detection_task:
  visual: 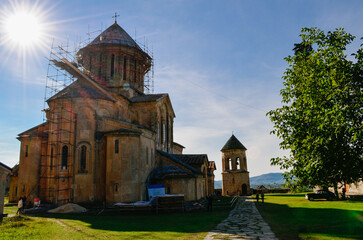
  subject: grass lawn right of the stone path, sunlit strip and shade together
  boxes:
[253,194,363,239]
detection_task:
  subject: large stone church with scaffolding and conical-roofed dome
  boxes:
[10,21,216,204]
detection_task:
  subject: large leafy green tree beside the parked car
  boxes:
[267,28,363,196]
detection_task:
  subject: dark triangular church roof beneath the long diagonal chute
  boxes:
[52,80,113,101]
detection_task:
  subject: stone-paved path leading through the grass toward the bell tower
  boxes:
[204,197,277,240]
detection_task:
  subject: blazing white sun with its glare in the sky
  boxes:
[0,0,52,60]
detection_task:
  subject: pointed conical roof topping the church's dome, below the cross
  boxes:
[88,22,142,50]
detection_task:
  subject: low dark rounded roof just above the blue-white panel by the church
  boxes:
[149,165,197,180]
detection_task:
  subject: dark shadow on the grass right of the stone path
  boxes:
[257,203,363,239]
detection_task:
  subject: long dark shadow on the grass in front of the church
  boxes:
[27,200,235,233]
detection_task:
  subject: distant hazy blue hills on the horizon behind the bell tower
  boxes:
[214,173,285,188]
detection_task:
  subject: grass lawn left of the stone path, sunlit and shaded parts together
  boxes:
[0,197,231,239]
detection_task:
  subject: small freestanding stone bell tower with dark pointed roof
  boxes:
[221,134,250,196]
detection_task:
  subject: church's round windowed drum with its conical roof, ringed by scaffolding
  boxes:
[77,22,152,94]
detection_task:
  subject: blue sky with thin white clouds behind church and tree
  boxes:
[0,0,363,180]
